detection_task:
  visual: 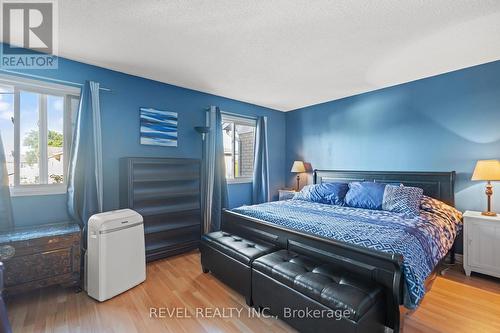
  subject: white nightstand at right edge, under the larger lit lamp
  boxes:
[464,211,500,277]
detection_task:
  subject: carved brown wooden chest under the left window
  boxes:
[0,222,81,294]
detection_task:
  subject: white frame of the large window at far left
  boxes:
[0,74,80,197]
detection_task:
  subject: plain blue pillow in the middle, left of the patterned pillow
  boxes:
[345,182,386,210]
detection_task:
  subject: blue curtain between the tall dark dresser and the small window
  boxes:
[202,106,228,232]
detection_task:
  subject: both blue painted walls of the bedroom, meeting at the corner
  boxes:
[7,49,500,233]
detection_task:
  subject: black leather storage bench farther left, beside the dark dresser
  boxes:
[200,231,275,305]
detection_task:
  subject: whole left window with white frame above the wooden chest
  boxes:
[0,75,80,196]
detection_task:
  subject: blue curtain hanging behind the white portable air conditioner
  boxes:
[67,81,103,248]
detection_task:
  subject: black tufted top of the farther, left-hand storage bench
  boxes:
[202,231,274,265]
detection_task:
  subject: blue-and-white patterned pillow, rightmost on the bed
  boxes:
[382,185,424,217]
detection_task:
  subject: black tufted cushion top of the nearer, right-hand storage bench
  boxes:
[252,250,383,321]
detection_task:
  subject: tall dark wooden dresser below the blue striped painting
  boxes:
[120,157,201,261]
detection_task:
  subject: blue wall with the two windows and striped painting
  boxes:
[8,55,285,225]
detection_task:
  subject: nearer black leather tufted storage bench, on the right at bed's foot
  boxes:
[252,250,385,333]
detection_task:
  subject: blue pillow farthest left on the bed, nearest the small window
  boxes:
[293,183,349,205]
